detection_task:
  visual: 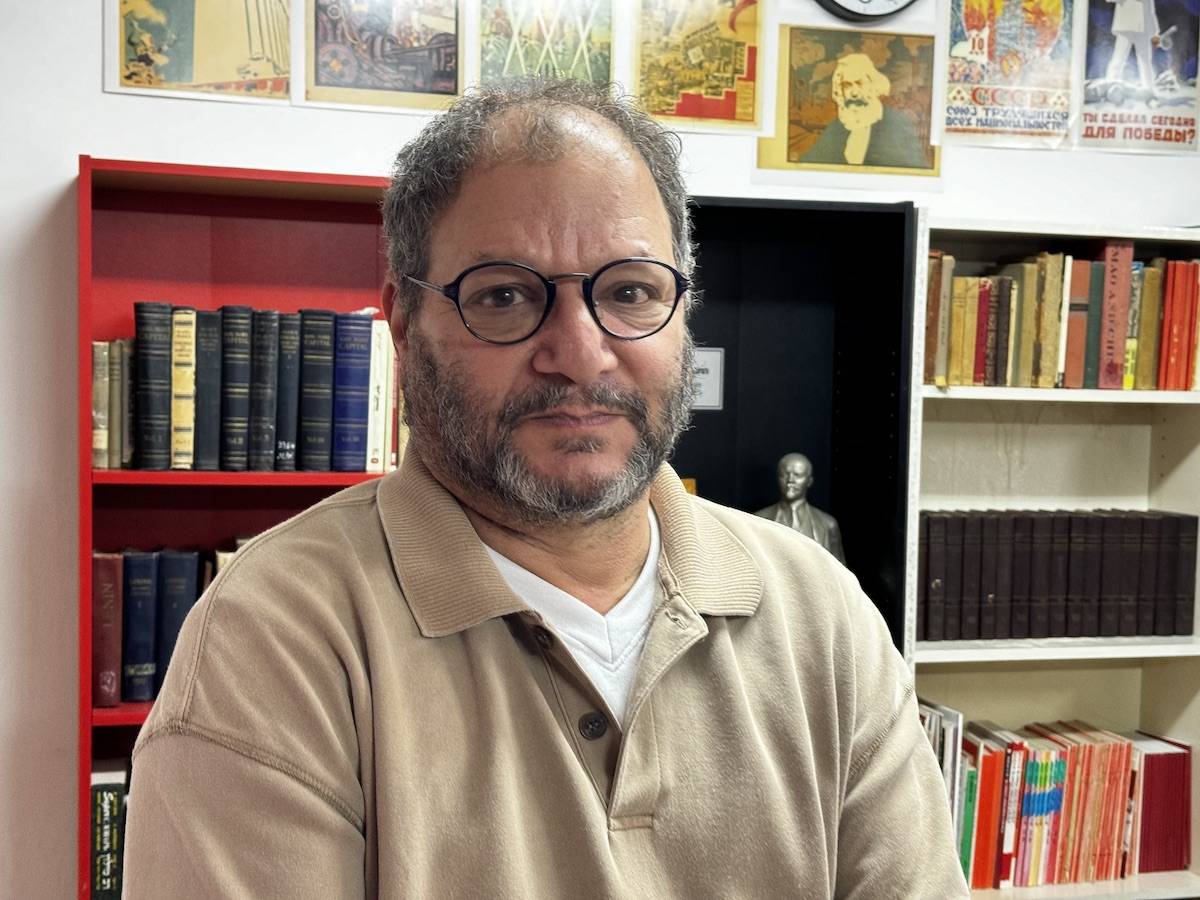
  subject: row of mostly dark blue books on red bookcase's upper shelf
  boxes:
[91,302,404,473]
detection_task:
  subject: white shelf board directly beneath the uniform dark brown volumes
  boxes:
[913,635,1200,666]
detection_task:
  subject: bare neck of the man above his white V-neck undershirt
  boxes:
[463,497,650,616]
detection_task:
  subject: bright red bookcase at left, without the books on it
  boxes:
[77,156,386,898]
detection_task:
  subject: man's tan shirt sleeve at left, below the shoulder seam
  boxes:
[122,733,365,900]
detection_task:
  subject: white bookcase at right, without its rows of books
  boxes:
[905,215,1200,900]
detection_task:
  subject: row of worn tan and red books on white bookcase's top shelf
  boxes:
[924,240,1200,390]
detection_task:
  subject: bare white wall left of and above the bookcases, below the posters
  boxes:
[0,0,1200,898]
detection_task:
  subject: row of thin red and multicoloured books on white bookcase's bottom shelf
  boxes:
[919,701,1192,889]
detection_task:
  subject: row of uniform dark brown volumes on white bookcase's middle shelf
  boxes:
[917,510,1198,641]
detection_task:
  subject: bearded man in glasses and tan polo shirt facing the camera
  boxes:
[126,83,966,899]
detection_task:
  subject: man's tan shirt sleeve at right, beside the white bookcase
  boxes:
[836,598,971,900]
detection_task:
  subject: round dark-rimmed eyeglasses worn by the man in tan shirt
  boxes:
[404,257,691,343]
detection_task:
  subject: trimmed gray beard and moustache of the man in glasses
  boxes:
[401,329,695,527]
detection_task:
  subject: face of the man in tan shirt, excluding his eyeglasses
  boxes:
[398,120,692,524]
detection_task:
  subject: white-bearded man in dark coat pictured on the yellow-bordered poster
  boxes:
[803,53,929,169]
